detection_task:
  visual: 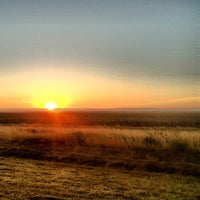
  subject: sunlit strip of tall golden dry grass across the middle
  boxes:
[0,125,200,151]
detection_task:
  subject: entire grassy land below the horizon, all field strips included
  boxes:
[0,112,200,199]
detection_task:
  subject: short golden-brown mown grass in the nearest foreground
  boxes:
[0,158,200,200]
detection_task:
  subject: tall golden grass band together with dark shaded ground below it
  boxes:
[0,125,200,177]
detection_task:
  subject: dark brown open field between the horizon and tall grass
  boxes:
[0,111,200,128]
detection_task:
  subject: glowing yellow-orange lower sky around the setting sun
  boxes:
[0,63,200,108]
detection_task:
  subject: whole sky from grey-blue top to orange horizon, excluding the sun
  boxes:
[0,0,200,109]
